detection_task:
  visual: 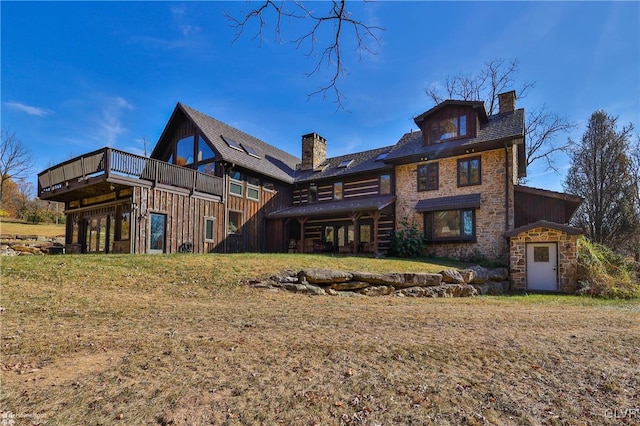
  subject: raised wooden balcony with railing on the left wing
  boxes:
[38,148,224,201]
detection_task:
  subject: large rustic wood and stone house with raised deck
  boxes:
[38,91,581,291]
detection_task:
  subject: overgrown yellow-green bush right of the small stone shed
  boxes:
[578,238,640,299]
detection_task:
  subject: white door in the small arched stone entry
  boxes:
[527,243,558,291]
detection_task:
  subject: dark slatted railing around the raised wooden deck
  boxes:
[38,148,223,198]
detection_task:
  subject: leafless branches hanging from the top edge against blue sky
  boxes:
[226,0,383,109]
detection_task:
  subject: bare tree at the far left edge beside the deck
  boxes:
[0,127,33,209]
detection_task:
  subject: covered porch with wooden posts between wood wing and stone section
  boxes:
[269,196,395,254]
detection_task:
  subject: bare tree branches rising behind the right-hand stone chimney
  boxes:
[426,58,575,171]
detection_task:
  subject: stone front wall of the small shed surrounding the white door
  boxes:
[510,227,580,293]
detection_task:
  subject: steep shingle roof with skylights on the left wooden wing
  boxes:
[178,103,301,183]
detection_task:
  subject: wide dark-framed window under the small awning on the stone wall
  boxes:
[424,209,476,241]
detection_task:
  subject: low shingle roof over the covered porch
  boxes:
[269,195,396,219]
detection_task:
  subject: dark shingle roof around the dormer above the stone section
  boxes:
[386,109,524,162]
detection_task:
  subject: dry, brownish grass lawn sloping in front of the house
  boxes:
[0,253,640,425]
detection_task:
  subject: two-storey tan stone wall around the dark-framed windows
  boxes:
[395,148,517,262]
